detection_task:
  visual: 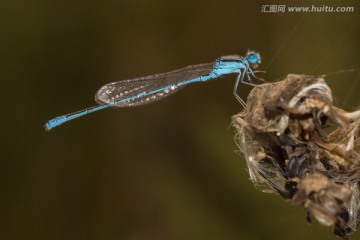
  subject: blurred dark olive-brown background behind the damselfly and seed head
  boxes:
[0,0,360,240]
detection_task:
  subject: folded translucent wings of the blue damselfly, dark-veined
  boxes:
[95,63,214,107]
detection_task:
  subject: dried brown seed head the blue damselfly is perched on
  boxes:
[233,74,360,237]
